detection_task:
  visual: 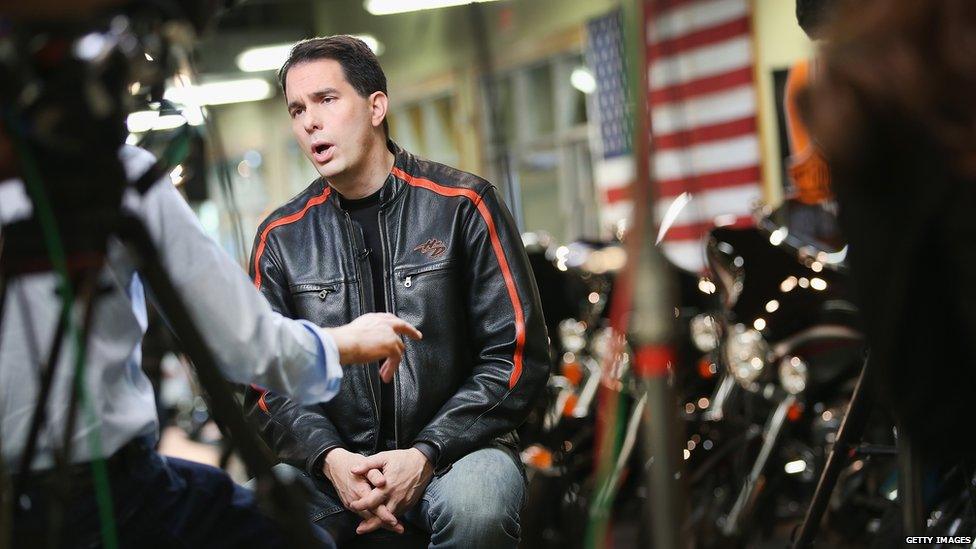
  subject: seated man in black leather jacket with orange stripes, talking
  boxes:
[245,36,549,547]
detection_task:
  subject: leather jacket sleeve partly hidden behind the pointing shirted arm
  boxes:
[244,228,342,476]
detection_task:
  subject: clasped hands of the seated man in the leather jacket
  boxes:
[322,448,434,534]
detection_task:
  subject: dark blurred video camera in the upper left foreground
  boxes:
[0,0,230,272]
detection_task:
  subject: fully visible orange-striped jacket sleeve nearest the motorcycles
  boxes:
[416,186,549,467]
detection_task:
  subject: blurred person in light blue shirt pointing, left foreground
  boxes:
[0,116,420,547]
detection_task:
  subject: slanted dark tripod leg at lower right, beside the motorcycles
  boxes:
[793,358,874,549]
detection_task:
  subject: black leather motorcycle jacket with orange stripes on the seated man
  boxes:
[245,143,549,474]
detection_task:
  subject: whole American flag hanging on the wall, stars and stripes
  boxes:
[587,0,762,272]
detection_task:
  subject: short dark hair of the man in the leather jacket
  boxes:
[278,34,390,136]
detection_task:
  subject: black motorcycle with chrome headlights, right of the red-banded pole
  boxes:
[687,202,896,546]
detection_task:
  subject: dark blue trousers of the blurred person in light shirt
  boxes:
[14,449,335,548]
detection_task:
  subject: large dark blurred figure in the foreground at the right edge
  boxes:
[809,0,976,463]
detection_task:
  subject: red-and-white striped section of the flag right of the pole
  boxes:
[645,0,762,271]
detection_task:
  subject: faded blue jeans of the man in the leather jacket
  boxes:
[277,445,525,549]
